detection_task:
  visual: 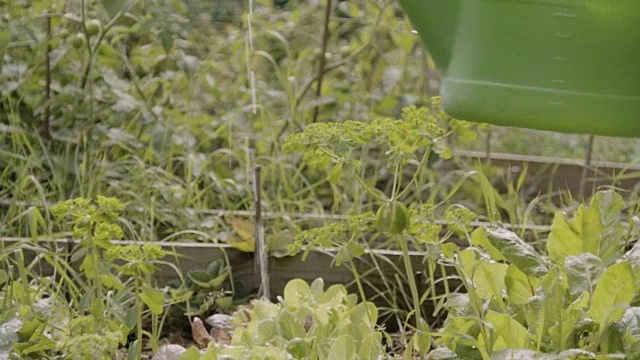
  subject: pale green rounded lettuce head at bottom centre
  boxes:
[204,279,383,360]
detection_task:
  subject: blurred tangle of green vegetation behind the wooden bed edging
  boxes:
[0,0,640,240]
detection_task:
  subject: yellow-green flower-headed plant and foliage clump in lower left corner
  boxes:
[0,196,175,359]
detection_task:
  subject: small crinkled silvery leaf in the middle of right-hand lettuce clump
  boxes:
[564,253,604,296]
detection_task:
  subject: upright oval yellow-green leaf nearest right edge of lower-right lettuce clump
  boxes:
[589,261,635,332]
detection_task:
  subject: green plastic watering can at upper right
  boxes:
[401,0,640,137]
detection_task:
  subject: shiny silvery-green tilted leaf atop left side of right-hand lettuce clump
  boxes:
[486,229,549,277]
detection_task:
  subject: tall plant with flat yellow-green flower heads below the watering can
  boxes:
[284,99,470,353]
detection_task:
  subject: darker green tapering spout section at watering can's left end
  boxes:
[400,0,461,70]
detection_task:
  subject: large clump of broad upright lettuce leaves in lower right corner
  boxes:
[437,191,640,359]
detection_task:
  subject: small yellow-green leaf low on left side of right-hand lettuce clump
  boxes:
[478,310,531,351]
